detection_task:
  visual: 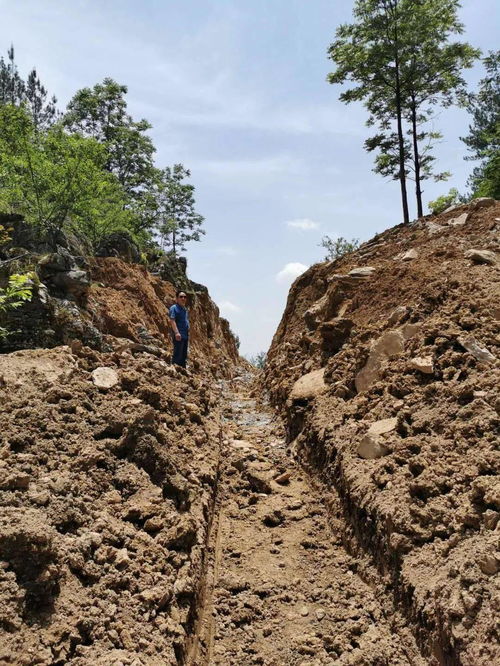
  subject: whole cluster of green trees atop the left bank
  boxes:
[0,48,205,255]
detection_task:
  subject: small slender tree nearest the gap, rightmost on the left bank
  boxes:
[156,164,205,254]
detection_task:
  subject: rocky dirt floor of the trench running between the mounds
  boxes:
[187,378,430,666]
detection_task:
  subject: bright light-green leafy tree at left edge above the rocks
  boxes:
[0,104,131,246]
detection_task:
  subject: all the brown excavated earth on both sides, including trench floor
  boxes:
[0,201,500,666]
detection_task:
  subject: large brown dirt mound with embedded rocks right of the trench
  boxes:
[266,200,500,666]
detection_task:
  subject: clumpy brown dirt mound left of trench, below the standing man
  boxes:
[0,344,227,666]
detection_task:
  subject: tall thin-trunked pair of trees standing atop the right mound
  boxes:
[328,0,479,223]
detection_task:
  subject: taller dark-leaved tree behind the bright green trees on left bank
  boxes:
[63,78,155,198]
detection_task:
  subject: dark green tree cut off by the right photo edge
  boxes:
[462,51,500,199]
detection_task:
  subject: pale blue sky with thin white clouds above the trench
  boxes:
[0,0,500,355]
